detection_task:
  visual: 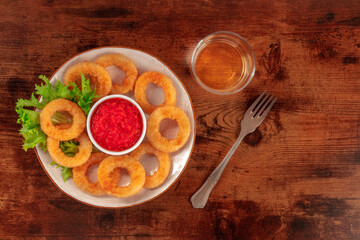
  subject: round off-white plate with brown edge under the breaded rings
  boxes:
[36,47,195,208]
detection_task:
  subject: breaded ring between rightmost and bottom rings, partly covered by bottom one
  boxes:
[130,143,171,188]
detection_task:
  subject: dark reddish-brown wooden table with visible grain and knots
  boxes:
[0,0,360,240]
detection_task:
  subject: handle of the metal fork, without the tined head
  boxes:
[190,131,247,208]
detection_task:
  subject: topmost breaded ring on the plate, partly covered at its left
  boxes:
[95,54,139,94]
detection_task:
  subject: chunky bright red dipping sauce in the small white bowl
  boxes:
[90,98,143,152]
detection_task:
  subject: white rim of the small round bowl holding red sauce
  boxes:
[86,94,146,155]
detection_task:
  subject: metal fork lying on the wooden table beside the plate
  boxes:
[190,91,277,208]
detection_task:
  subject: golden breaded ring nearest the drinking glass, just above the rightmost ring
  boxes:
[134,72,176,114]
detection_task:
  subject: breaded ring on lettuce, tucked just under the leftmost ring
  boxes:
[46,132,92,168]
